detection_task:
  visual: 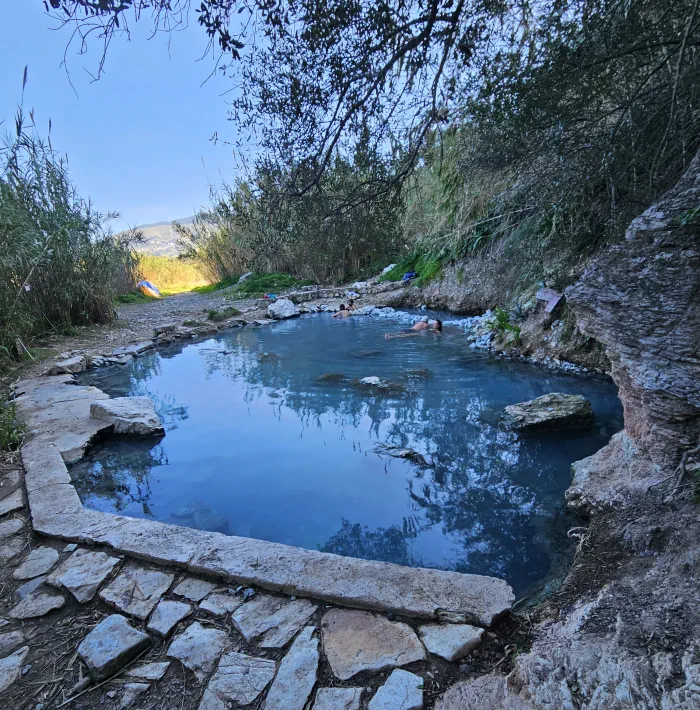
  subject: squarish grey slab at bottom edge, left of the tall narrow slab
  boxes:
[200,652,277,707]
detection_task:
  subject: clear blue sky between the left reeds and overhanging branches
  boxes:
[0,0,234,230]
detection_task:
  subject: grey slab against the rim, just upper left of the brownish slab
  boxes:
[231,594,317,648]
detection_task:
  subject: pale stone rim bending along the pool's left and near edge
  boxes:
[10,342,515,626]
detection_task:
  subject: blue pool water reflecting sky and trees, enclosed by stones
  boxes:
[71,314,622,594]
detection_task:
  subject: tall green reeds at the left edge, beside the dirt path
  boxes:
[0,98,137,368]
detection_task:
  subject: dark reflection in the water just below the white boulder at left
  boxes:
[70,437,168,516]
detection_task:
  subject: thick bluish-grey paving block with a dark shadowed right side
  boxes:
[78,614,151,681]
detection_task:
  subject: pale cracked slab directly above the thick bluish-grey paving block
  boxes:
[100,565,175,619]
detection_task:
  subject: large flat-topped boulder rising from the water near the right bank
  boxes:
[503,392,595,432]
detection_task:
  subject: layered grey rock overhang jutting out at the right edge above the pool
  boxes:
[566,154,700,466]
